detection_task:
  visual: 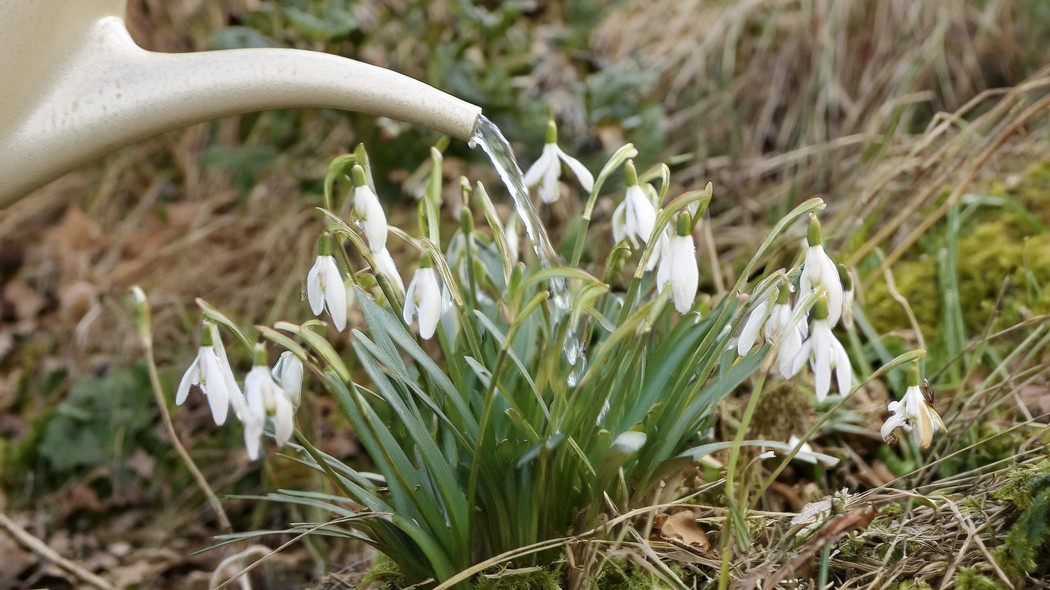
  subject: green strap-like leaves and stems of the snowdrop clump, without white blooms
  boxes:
[197,144,835,588]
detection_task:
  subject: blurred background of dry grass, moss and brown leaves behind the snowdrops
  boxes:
[6,0,1050,586]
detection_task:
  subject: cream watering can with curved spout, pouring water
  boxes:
[0,0,481,207]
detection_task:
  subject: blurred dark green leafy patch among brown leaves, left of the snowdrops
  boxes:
[38,365,156,473]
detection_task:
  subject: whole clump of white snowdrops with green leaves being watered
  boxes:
[159,124,928,586]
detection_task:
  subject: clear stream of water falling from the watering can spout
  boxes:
[470,115,585,369]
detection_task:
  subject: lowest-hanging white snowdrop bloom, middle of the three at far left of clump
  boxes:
[245,343,295,460]
